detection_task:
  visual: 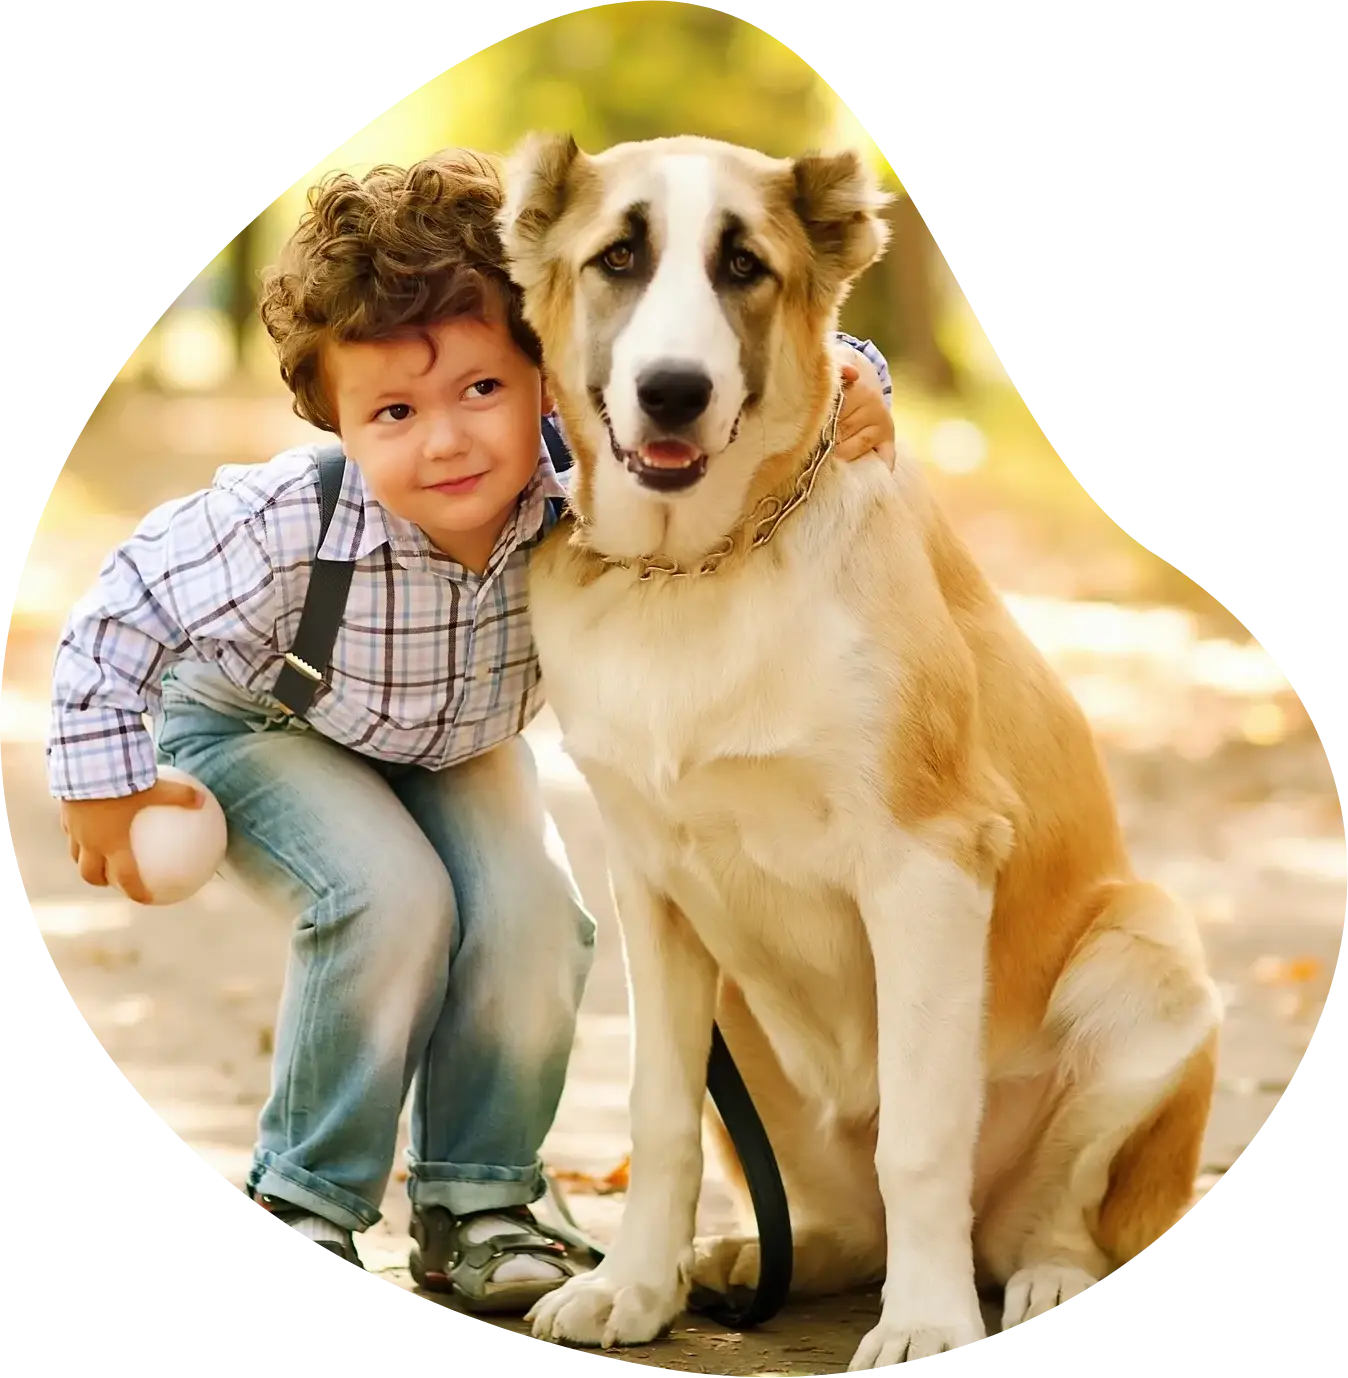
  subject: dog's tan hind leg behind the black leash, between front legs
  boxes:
[693,980,885,1297]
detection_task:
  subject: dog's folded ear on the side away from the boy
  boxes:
[791,149,893,295]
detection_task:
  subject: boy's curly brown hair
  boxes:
[261,149,543,431]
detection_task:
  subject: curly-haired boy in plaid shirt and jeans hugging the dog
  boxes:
[48,150,893,1312]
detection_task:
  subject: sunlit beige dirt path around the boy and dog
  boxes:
[0,385,1348,1378]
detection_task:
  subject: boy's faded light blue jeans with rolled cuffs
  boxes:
[156,671,595,1231]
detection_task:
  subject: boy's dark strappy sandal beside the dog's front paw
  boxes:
[409,1206,593,1315]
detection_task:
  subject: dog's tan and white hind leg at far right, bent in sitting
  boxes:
[976,885,1221,1330]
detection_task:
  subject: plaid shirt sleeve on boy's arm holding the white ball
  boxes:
[47,488,276,799]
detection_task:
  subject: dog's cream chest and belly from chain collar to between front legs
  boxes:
[535,548,884,1113]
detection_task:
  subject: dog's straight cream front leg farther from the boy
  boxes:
[848,835,992,1374]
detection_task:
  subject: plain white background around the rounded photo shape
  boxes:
[15,6,1344,1374]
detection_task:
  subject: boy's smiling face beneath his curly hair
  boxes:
[323,299,551,572]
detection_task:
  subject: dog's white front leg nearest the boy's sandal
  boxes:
[525,847,717,1349]
